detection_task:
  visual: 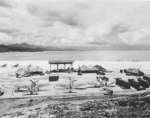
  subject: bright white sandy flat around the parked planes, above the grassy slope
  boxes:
[0,61,145,98]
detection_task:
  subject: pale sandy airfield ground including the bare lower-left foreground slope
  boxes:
[0,61,150,118]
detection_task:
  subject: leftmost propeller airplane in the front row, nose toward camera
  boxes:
[15,80,50,95]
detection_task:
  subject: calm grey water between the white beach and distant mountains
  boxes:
[0,51,150,61]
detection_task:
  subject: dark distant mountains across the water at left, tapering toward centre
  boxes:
[0,43,78,52]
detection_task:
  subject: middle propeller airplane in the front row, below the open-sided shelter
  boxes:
[55,77,85,93]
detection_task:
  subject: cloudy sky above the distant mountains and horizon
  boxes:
[0,0,150,47]
